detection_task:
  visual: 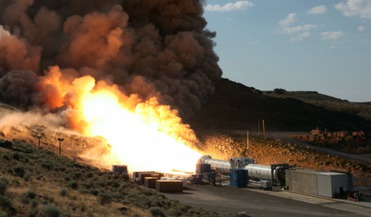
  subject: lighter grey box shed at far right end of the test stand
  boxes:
[316,172,351,198]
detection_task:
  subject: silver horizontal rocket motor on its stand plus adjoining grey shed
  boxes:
[191,155,353,197]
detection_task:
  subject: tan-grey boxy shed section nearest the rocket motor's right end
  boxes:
[285,169,318,195]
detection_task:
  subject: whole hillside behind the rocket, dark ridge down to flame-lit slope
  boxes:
[189,79,371,186]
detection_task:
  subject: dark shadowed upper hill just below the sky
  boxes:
[189,79,371,132]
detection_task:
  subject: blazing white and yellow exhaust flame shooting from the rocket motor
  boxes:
[44,69,202,172]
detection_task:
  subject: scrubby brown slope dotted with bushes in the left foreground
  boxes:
[0,140,218,217]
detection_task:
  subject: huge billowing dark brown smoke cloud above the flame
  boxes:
[0,0,222,115]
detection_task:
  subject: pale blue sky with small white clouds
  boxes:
[204,0,371,102]
